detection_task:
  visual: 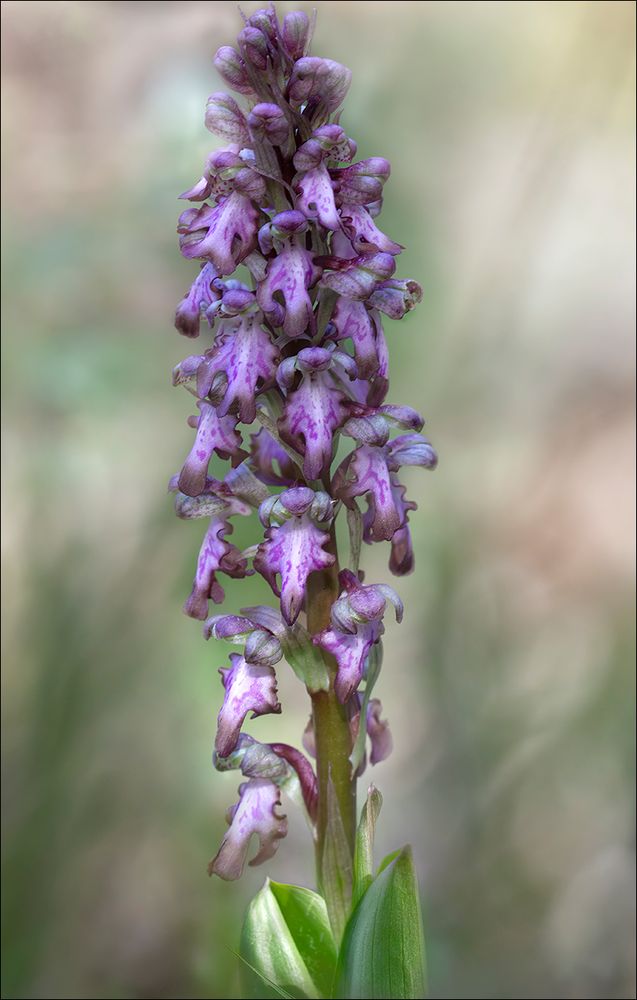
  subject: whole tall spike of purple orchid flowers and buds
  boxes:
[171,9,436,879]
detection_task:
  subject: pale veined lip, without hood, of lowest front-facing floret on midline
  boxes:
[254,514,335,625]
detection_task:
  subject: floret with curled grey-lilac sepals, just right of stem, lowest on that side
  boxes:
[314,570,403,703]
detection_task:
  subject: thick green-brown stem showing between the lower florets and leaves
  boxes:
[306,528,356,936]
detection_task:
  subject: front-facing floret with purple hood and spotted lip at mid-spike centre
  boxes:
[278,347,355,480]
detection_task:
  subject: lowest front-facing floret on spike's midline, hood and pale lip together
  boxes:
[254,487,335,625]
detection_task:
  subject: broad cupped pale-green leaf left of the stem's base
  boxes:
[240,879,336,998]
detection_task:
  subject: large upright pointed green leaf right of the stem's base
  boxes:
[334,847,426,1000]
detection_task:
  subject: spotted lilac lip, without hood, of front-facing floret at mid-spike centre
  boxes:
[279,366,349,479]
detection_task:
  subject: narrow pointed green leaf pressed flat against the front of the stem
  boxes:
[320,778,353,943]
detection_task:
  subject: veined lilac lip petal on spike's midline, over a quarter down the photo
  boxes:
[257,245,321,339]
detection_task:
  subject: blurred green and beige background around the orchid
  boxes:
[2,0,635,1000]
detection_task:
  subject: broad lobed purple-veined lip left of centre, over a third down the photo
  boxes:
[201,312,279,424]
